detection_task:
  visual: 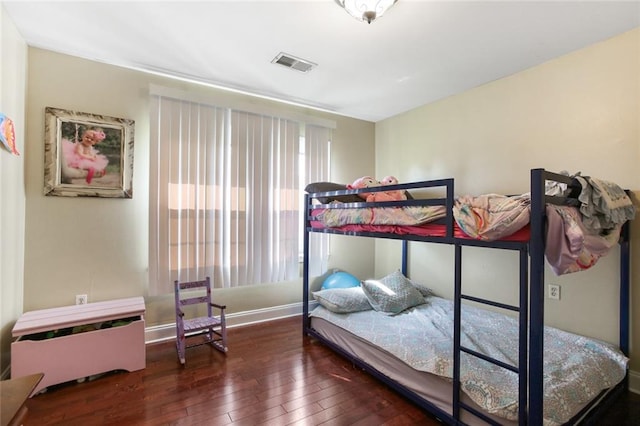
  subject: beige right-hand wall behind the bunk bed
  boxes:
[376,29,640,371]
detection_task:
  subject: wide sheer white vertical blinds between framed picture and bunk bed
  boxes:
[149,95,301,294]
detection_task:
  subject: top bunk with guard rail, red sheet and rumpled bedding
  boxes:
[305,169,636,260]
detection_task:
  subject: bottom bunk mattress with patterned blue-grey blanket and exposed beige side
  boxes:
[307,296,628,425]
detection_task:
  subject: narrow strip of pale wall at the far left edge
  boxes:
[0,5,27,373]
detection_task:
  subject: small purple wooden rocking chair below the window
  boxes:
[174,277,227,365]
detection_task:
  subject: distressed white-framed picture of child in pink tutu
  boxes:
[44,107,135,198]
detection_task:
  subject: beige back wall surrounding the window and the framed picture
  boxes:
[24,48,374,326]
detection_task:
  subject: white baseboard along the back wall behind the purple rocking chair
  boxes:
[144,301,317,344]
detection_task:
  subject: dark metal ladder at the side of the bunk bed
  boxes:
[453,243,529,425]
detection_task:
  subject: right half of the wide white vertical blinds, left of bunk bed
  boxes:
[229,111,300,286]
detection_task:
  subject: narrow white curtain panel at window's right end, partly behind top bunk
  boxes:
[304,124,332,276]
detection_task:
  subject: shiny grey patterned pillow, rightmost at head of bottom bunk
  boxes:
[361,271,425,315]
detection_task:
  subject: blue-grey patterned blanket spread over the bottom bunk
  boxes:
[311,296,628,425]
